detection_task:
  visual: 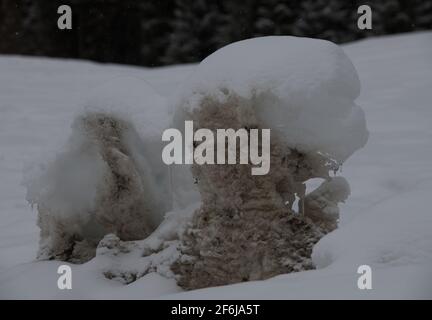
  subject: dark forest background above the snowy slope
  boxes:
[0,0,432,66]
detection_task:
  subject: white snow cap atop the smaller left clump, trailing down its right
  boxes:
[83,76,172,210]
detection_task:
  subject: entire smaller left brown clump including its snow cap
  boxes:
[27,79,170,262]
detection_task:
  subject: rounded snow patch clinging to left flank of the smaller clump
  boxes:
[24,130,107,222]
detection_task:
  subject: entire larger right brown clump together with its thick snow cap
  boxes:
[169,37,367,289]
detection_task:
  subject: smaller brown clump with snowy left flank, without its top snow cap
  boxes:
[27,113,166,262]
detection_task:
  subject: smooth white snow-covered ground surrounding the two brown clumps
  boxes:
[0,33,432,299]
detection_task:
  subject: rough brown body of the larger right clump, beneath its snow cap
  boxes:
[173,94,339,289]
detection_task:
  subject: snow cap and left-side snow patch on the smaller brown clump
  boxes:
[24,76,171,224]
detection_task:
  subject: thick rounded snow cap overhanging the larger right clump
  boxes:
[178,36,368,162]
